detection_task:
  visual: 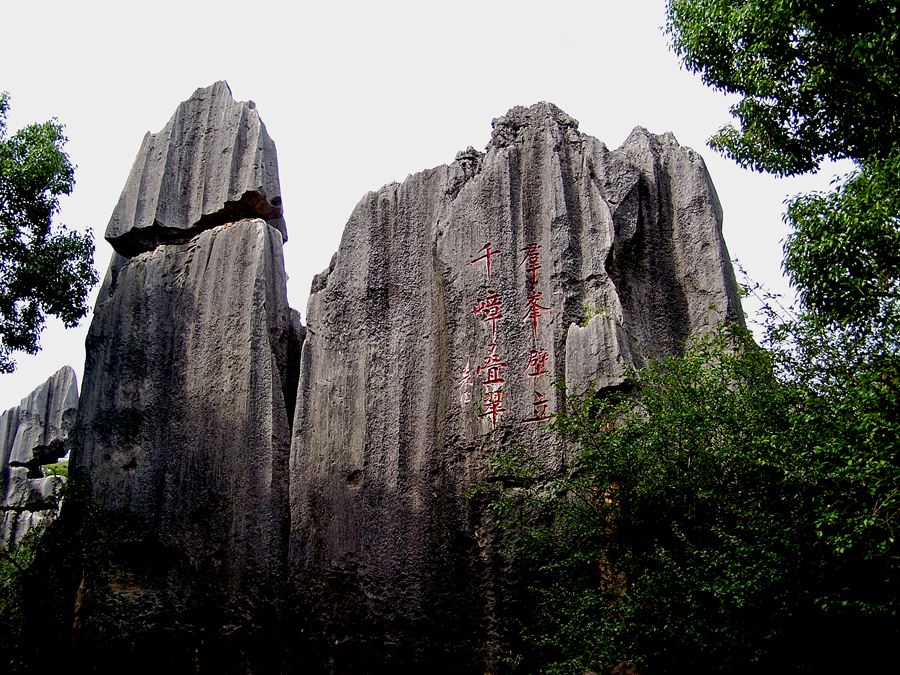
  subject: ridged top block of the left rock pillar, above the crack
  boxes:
[106,81,287,257]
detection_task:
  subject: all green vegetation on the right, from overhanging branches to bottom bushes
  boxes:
[491,0,900,673]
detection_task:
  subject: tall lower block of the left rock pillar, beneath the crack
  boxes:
[73,220,299,628]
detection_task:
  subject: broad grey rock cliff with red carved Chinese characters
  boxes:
[290,103,741,672]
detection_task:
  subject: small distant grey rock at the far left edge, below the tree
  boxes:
[0,366,78,547]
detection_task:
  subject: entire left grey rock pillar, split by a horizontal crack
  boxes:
[72,83,303,654]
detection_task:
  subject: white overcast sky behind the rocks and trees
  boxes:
[0,0,834,410]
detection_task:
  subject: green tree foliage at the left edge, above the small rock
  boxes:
[0,93,97,372]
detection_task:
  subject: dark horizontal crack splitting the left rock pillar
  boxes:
[107,190,287,258]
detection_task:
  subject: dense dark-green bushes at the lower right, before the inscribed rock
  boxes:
[491,324,900,673]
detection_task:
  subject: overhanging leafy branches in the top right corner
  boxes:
[667,0,900,175]
